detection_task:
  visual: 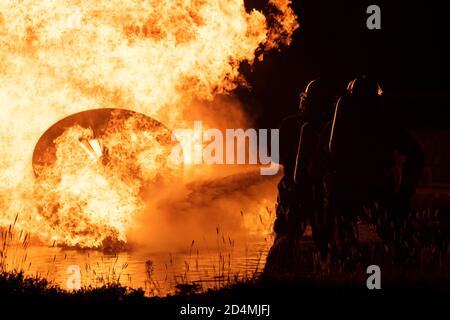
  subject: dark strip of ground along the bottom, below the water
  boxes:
[0,273,450,319]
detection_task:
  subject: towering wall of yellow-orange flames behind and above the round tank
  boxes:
[0,0,297,248]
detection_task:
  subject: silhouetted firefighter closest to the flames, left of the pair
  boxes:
[266,79,336,270]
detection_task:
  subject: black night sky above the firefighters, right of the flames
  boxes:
[238,0,450,127]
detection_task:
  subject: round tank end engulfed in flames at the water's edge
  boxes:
[33,109,177,249]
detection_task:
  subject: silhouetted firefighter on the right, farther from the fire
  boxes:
[327,77,423,258]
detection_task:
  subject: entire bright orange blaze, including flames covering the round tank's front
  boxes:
[0,0,297,247]
